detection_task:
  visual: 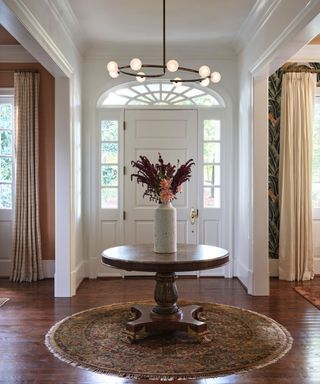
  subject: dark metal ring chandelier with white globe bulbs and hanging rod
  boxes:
[107,0,221,87]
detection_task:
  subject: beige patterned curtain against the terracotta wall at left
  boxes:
[11,72,43,282]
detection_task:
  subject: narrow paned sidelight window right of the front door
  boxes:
[203,120,221,208]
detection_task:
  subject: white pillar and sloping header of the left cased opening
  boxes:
[0,0,84,296]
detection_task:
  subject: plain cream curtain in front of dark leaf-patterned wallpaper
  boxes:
[279,73,316,281]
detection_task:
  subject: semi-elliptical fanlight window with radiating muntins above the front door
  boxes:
[98,82,225,107]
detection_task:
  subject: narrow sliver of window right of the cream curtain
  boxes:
[312,87,320,209]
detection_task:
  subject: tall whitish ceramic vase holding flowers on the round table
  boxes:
[154,203,177,253]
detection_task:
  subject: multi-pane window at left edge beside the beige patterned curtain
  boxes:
[0,90,14,209]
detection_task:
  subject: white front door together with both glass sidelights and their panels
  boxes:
[92,109,232,277]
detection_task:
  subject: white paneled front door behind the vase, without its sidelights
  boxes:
[124,110,198,249]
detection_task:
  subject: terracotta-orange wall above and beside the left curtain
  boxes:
[0,63,55,260]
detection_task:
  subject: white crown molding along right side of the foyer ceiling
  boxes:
[233,0,281,54]
